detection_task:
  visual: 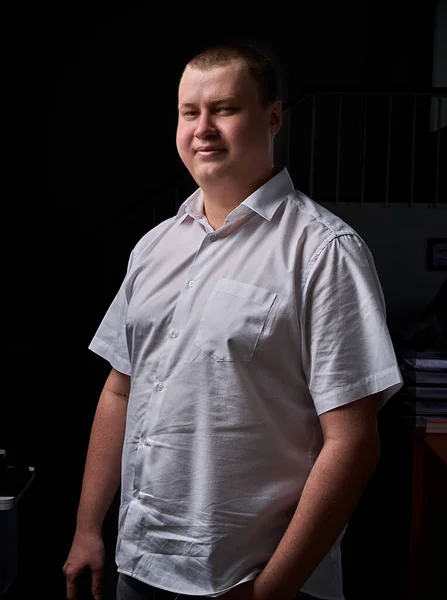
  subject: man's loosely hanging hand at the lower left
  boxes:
[62,532,105,600]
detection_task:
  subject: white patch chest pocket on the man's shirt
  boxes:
[194,278,276,362]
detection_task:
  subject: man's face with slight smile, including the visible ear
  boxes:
[177,60,281,187]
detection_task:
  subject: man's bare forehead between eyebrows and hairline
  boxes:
[178,60,257,104]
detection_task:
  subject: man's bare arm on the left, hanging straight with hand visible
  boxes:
[63,369,130,600]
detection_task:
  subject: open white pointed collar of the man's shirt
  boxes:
[175,167,294,221]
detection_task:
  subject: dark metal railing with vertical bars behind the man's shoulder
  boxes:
[285,88,447,208]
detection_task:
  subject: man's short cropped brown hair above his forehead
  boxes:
[183,42,278,106]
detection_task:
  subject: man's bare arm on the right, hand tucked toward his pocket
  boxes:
[253,396,380,600]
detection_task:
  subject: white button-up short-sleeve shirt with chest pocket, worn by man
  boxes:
[89,169,402,600]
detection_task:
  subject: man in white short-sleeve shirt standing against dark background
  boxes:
[64,45,402,600]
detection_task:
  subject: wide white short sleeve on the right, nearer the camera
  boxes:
[301,234,402,414]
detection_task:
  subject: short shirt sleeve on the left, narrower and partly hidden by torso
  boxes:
[88,250,133,375]
